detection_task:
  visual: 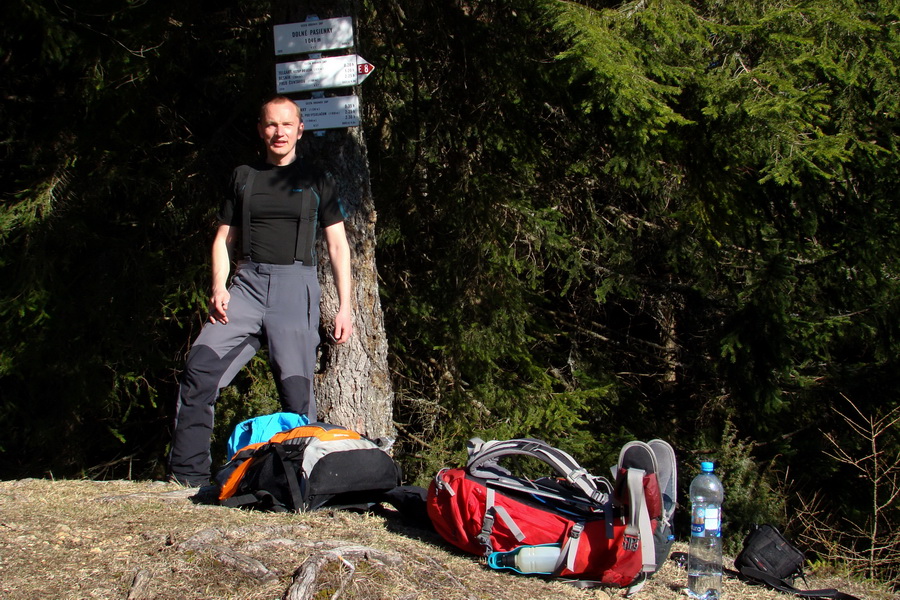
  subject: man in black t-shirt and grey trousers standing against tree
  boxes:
[169,96,353,487]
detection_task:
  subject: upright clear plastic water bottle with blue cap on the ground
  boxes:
[688,462,725,600]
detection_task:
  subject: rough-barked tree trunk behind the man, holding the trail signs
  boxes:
[273,0,394,438]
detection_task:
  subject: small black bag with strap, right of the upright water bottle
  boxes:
[728,525,859,600]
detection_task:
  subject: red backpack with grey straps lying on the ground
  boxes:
[427,439,674,591]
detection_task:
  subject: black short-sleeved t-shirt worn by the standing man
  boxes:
[218,159,344,265]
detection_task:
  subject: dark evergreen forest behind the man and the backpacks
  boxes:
[0,0,900,584]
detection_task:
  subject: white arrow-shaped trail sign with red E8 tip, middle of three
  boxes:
[275,54,375,94]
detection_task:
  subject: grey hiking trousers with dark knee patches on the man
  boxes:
[169,260,321,485]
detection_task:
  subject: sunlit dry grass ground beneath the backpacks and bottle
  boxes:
[0,479,891,600]
